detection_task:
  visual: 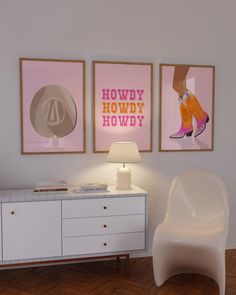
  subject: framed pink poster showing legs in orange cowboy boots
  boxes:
[159,64,215,151]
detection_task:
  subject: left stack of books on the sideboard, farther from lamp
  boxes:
[33,180,68,193]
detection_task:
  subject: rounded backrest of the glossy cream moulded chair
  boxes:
[165,170,229,232]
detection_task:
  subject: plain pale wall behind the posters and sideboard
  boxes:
[0,0,236,253]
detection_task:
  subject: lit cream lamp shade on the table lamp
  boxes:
[107,142,141,163]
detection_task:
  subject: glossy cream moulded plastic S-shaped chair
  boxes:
[153,171,229,295]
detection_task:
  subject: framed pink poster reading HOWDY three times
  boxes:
[93,61,153,152]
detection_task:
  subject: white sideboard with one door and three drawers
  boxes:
[0,186,147,267]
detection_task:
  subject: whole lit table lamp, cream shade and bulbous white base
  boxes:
[107,142,141,190]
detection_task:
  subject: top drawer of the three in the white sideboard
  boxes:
[62,197,145,218]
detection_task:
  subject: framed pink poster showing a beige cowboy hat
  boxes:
[20,58,85,154]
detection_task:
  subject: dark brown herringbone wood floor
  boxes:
[0,250,236,295]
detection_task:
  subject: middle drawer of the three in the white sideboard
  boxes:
[62,215,145,237]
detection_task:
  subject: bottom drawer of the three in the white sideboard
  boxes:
[63,233,145,255]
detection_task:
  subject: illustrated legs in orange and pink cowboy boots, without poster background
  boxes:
[170,65,209,138]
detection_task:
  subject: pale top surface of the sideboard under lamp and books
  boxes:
[0,185,147,203]
